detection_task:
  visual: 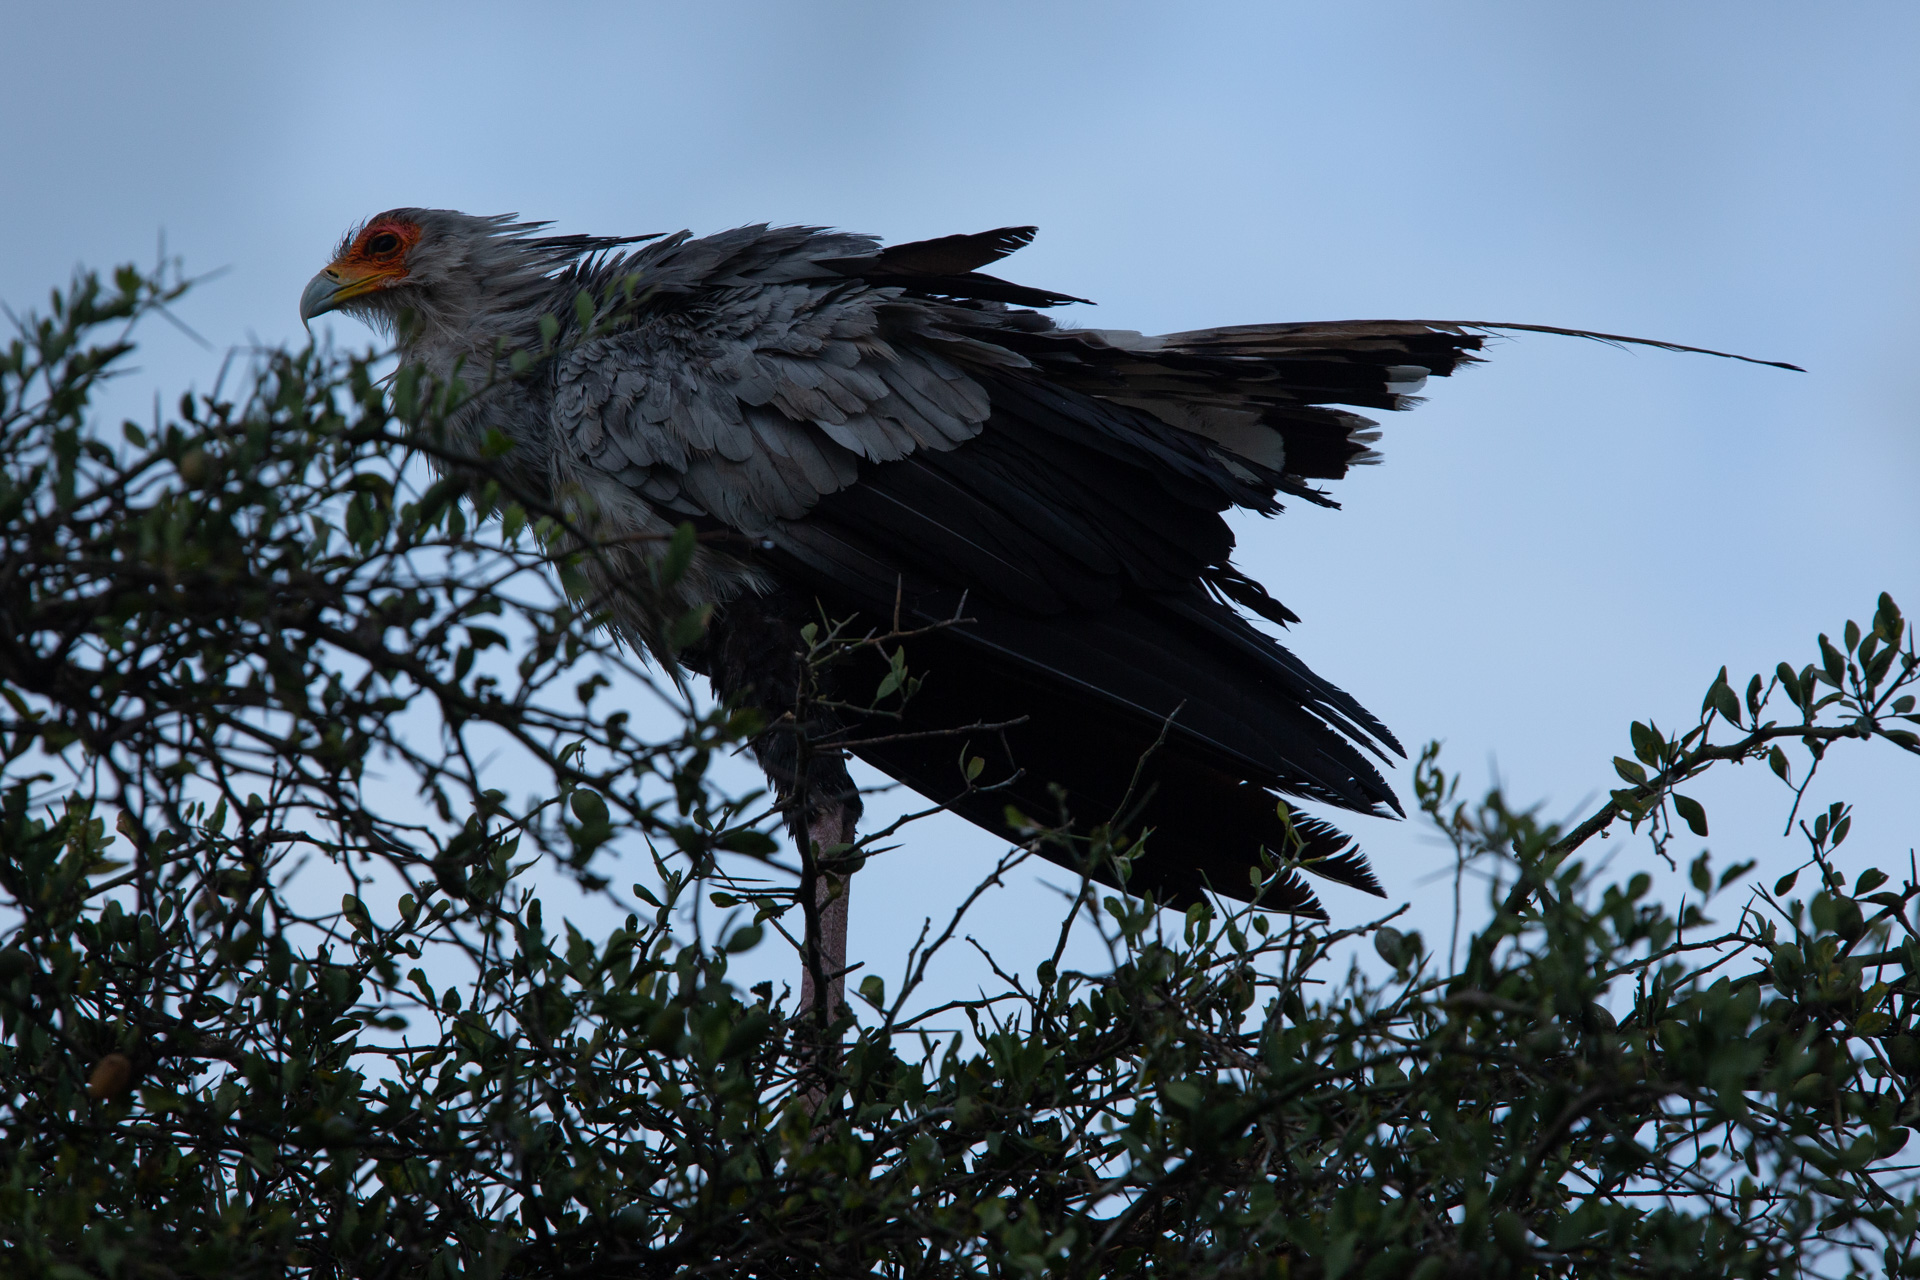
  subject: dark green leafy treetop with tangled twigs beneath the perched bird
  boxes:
[11,271,1920,1280]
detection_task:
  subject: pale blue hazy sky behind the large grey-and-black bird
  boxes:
[0,0,1920,990]
